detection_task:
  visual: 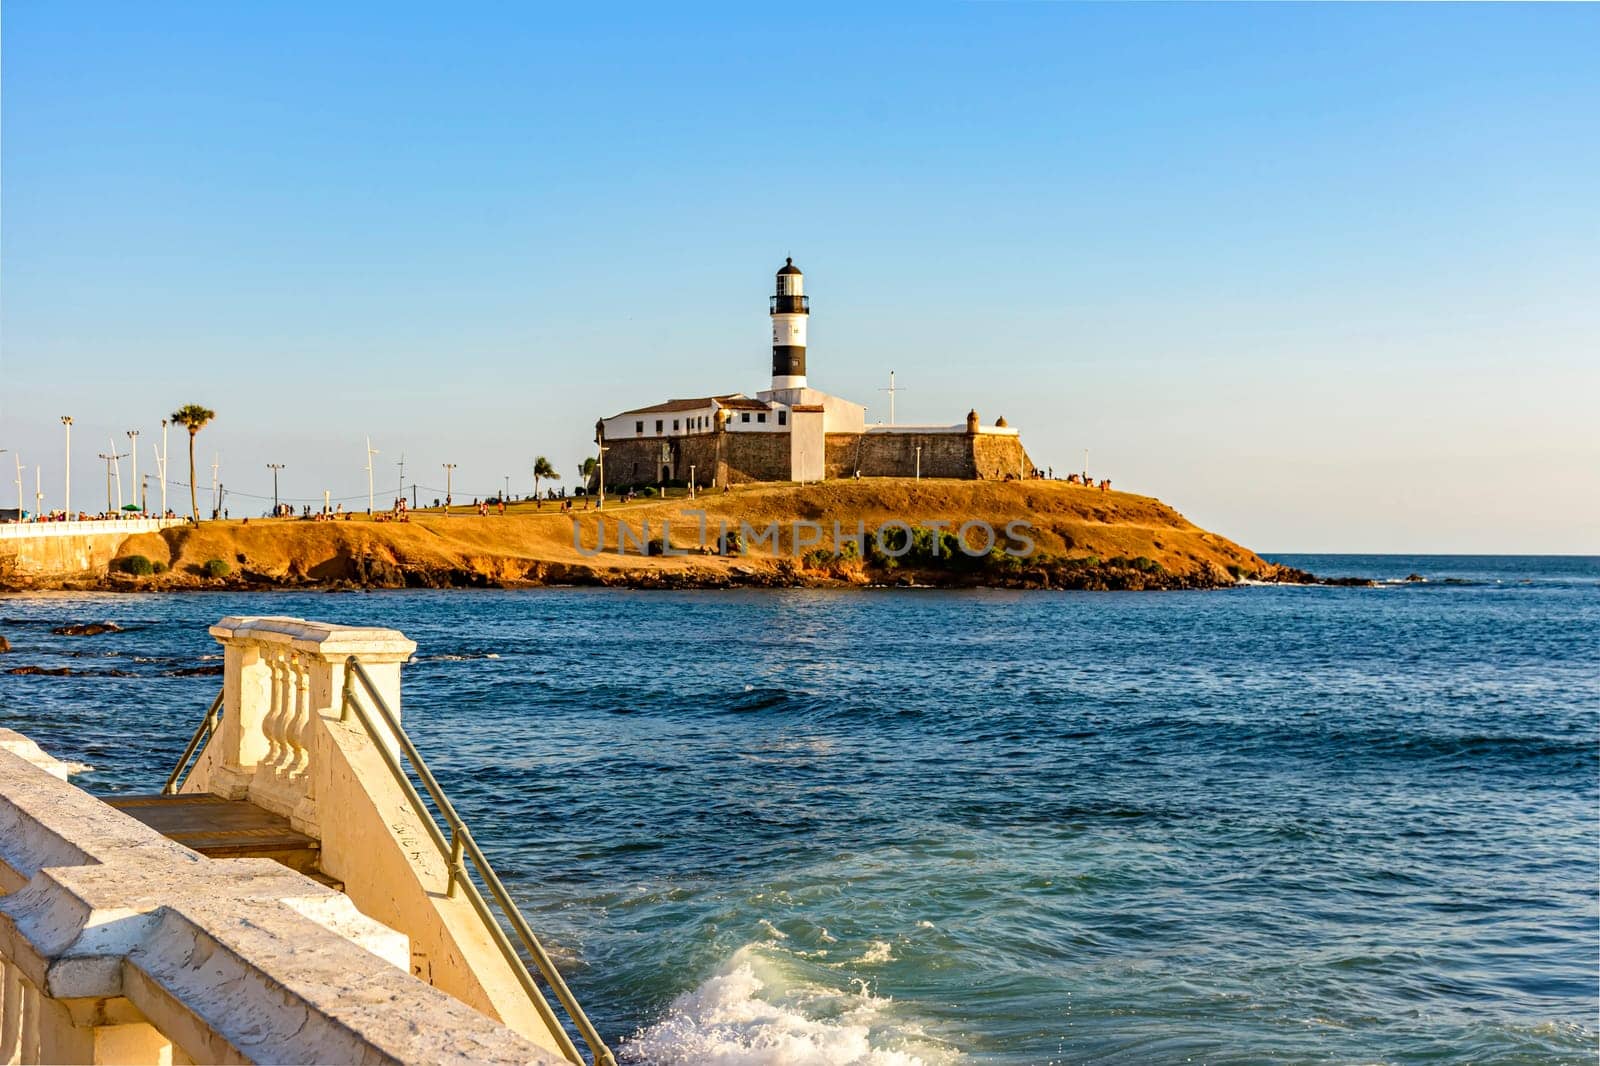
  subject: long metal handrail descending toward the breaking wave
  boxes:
[339,655,616,1066]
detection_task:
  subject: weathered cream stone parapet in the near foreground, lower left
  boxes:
[0,731,560,1063]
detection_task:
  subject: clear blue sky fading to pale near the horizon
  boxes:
[0,0,1600,552]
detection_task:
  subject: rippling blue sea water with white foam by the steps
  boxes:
[0,555,1600,1066]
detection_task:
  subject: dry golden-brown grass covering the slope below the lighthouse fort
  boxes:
[120,479,1269,586]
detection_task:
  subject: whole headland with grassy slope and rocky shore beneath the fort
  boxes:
[0,479,1293,591]
